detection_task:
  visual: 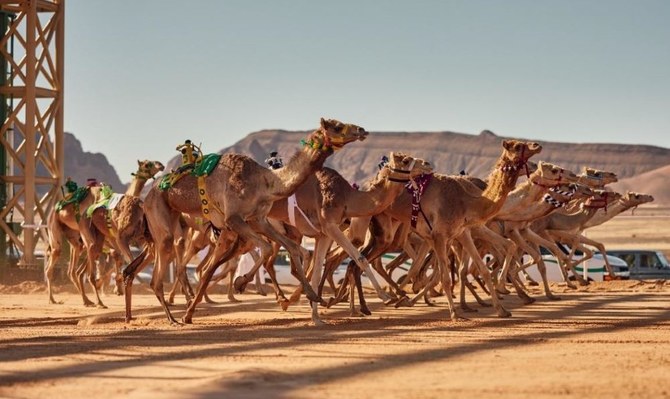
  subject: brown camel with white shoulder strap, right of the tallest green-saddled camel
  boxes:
[255,152,432,325]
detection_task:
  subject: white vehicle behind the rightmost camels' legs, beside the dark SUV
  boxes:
[523,244,630,282]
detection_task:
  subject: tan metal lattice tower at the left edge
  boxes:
[0,0,65,265]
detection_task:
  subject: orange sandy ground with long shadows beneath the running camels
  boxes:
[0,281,670,398]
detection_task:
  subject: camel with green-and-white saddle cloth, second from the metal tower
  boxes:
[80,160,165,295]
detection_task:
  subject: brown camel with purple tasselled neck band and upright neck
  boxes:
[344,140,542,320]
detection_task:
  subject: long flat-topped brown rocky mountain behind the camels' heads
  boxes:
[168,130,670,204]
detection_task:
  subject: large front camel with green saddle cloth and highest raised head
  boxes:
[124,118,368,324]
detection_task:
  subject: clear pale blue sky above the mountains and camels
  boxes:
[64,0,670,182]
